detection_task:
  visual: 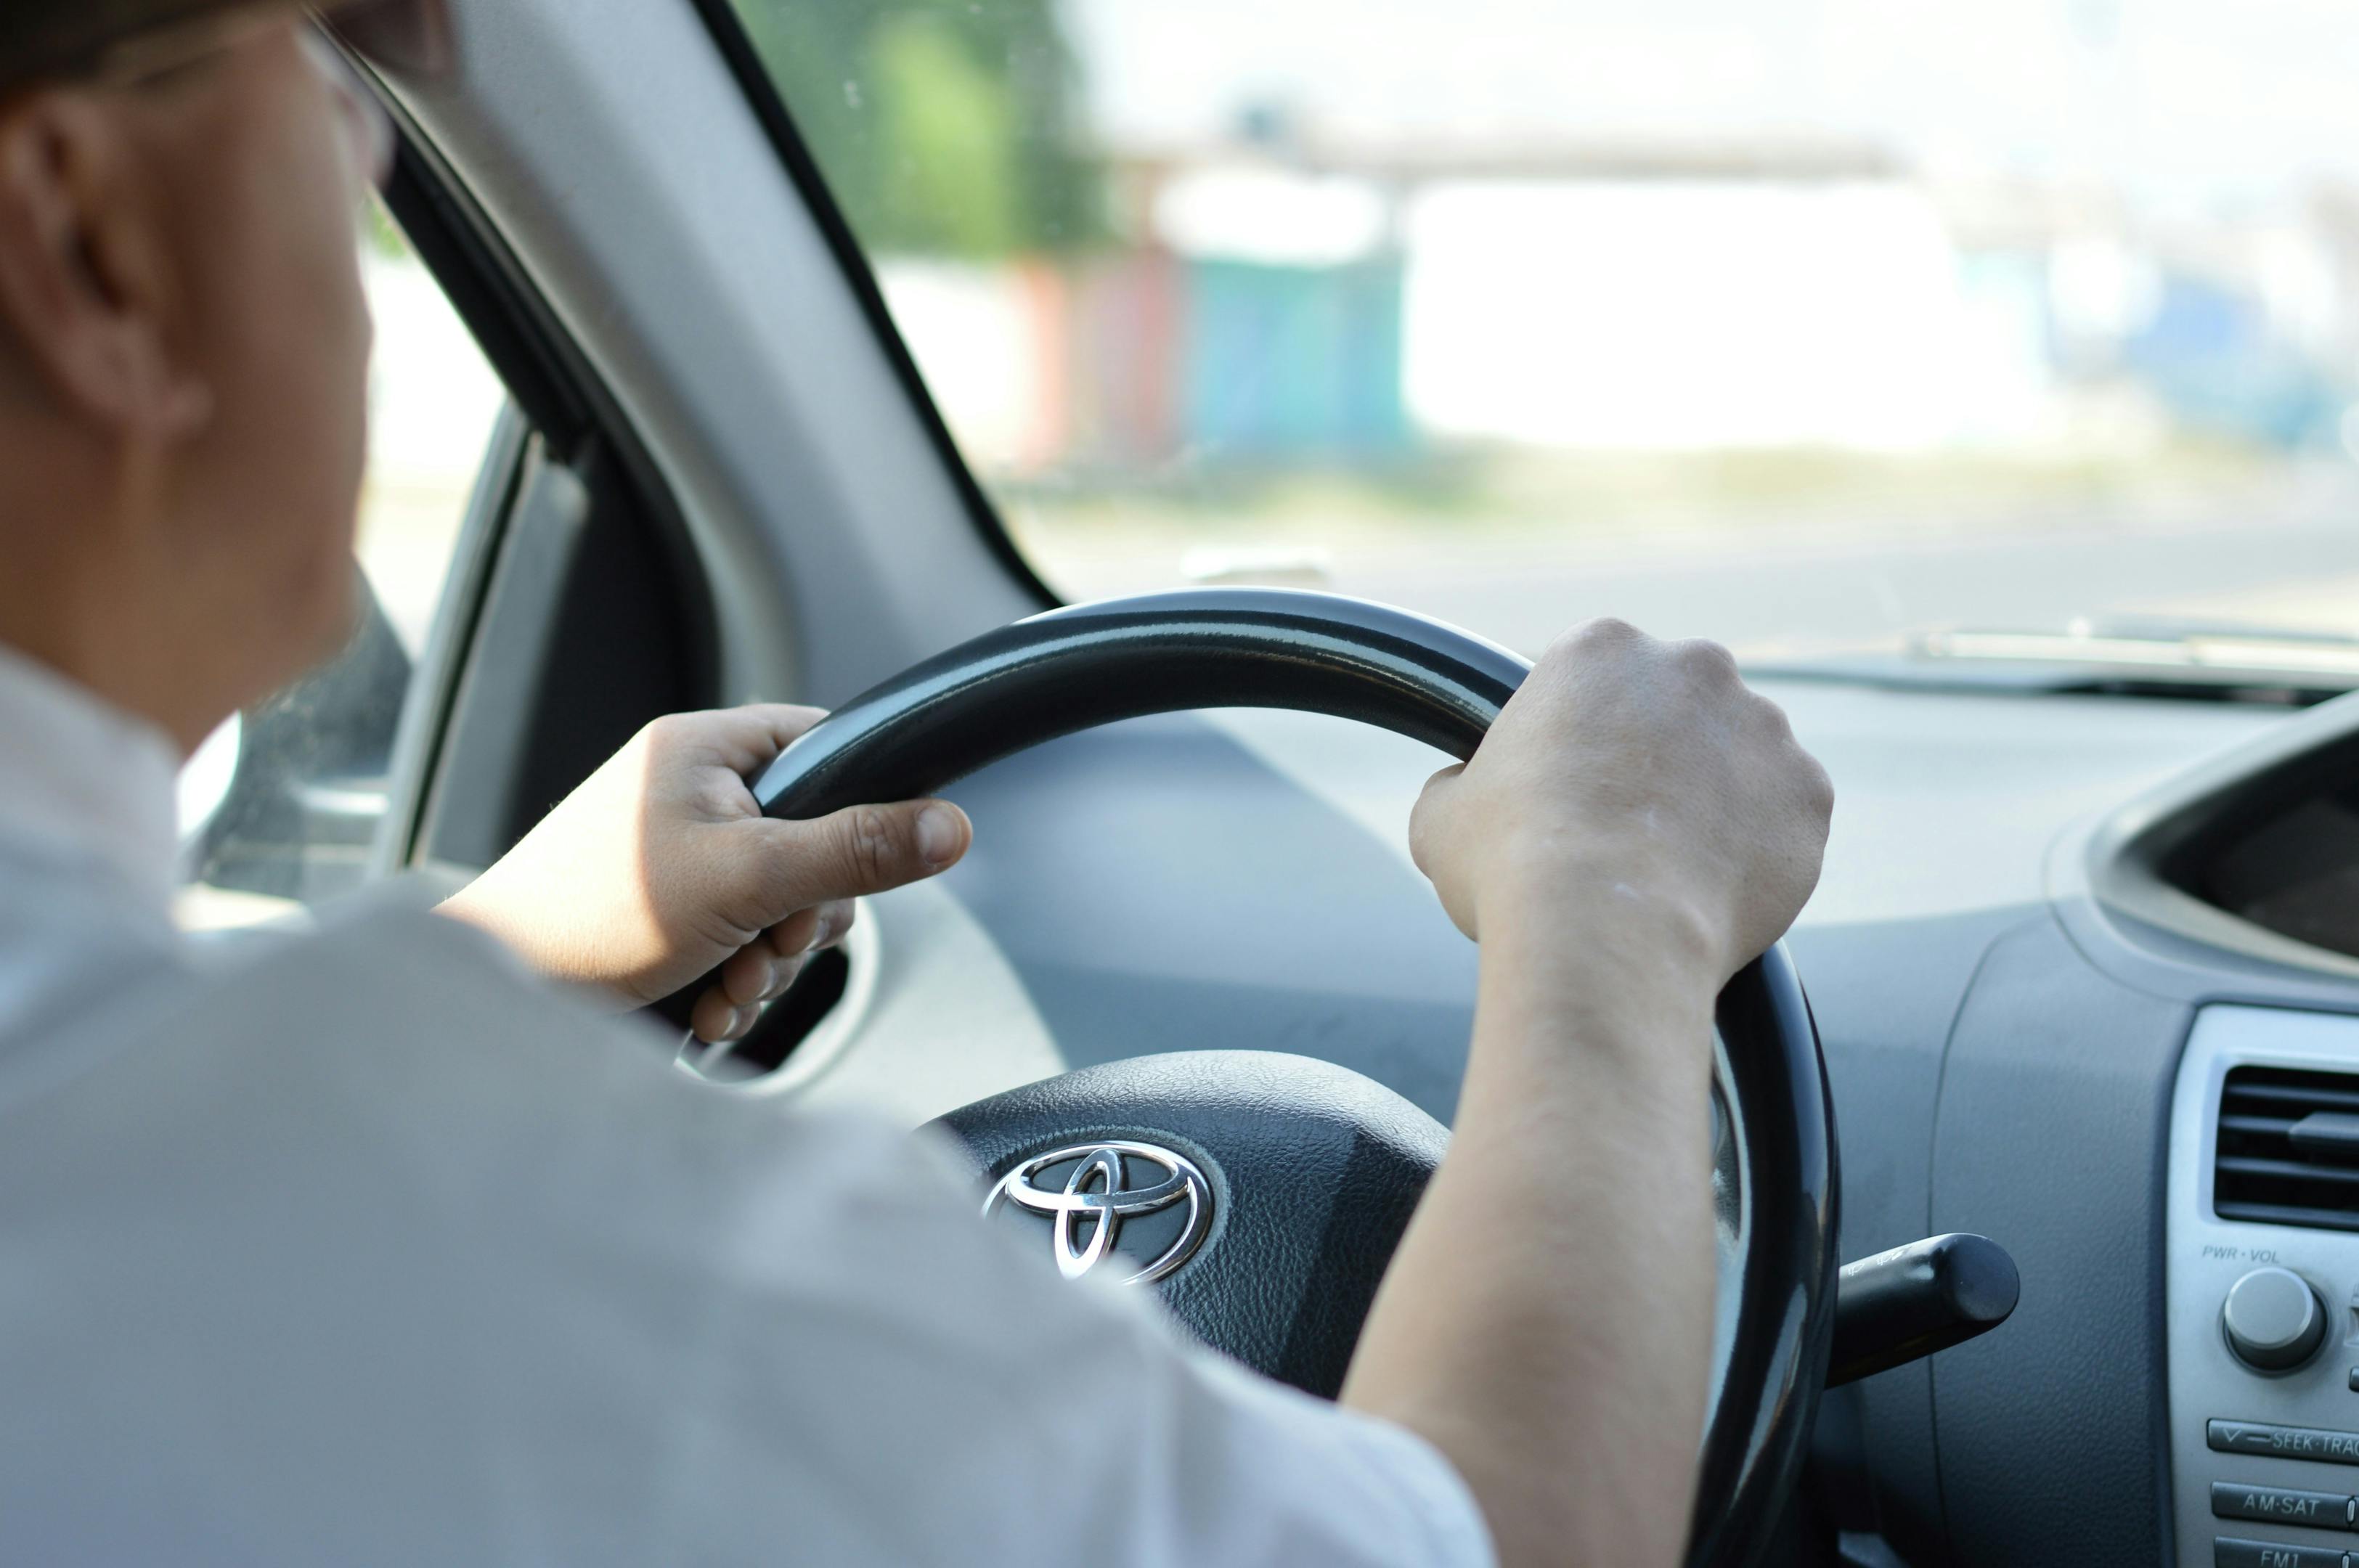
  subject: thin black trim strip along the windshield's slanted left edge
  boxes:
[691,0,1064,611]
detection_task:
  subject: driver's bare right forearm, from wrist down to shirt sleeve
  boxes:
[1345,901,1713,1568]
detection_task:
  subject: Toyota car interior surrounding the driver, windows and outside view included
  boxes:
[179,0,2359,1568]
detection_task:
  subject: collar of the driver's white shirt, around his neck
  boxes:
[0,644,179,920]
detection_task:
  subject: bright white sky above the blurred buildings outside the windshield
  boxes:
[1067,0,2359,219]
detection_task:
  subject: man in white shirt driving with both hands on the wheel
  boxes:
[0,0,1830,1568]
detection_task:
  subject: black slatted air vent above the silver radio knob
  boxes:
[2213,1068,2359,1231]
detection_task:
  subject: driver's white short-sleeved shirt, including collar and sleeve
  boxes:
[0,650,1491,1568]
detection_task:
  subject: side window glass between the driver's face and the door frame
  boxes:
[179,197,508,929]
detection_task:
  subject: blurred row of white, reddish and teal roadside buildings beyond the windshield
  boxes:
[882,125,2359,478]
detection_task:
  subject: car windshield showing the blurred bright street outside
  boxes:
[717,0,2359,660]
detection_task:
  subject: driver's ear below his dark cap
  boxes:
[0,89,212,444]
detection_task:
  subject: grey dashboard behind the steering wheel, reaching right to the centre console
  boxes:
[783,682,2359,1568]
